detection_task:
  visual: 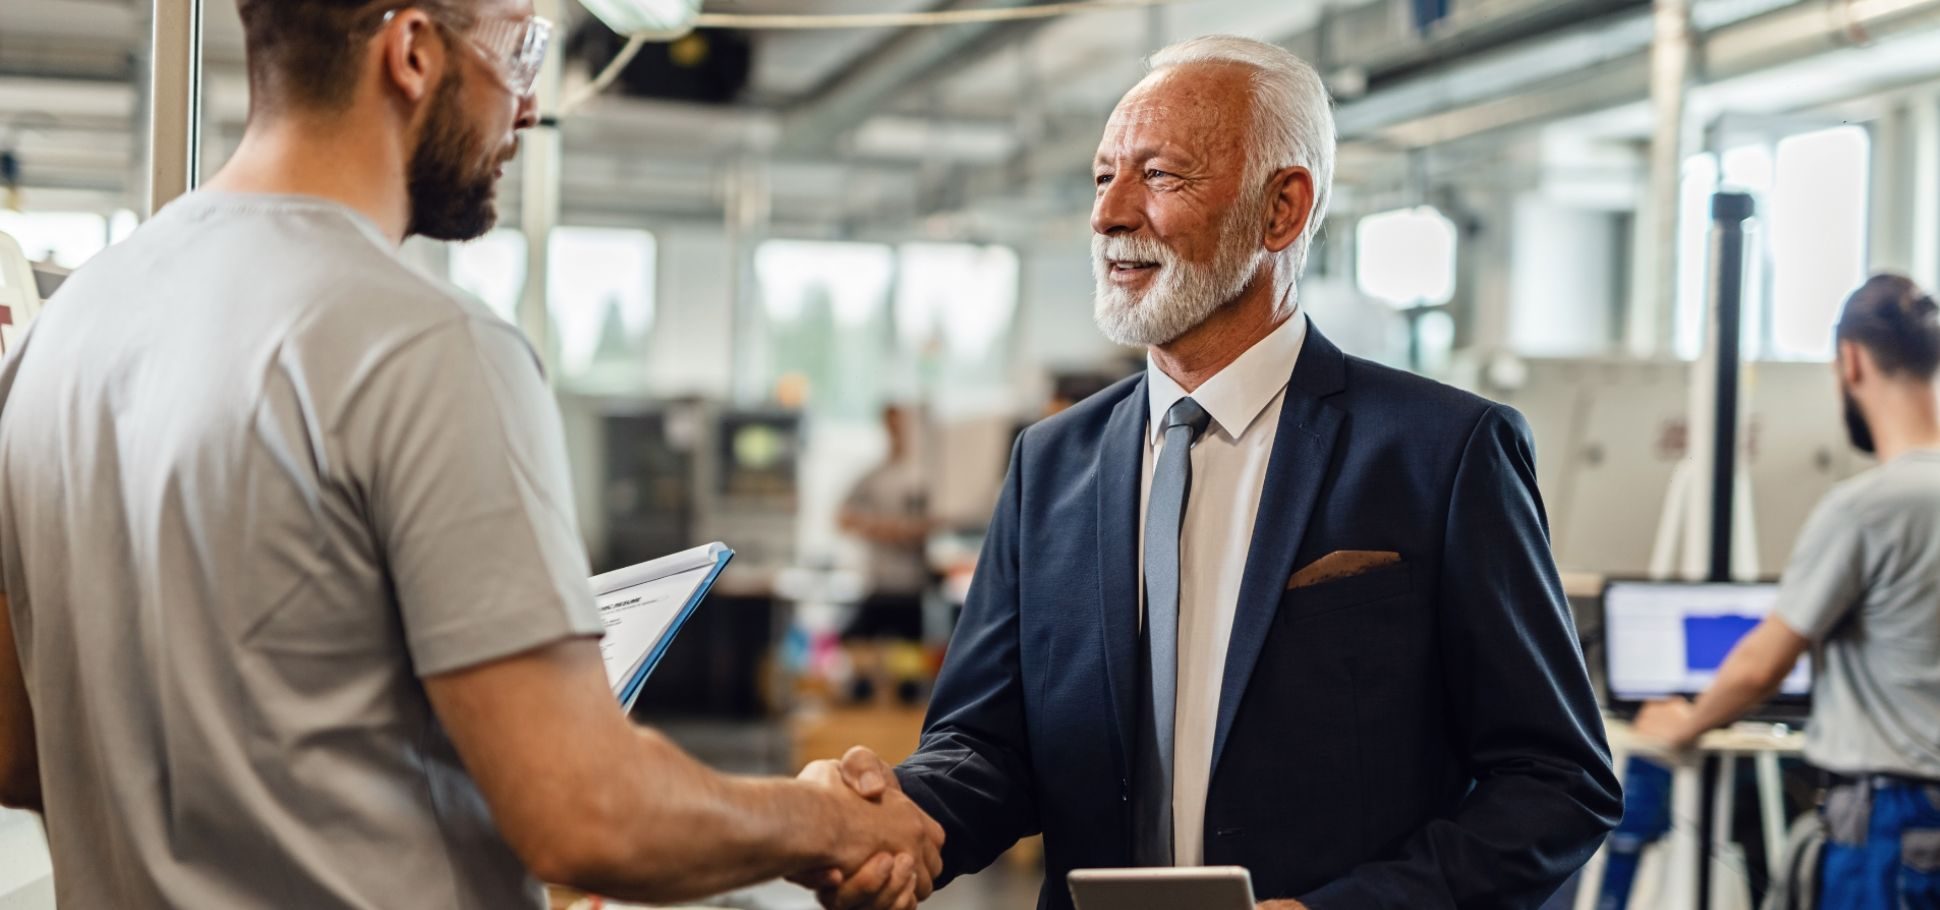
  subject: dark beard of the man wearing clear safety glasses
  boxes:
[407,72,499,241]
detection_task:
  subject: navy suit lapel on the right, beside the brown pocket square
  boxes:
[1210,322,1346,774]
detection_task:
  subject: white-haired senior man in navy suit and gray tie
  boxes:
[803,37,1622,910]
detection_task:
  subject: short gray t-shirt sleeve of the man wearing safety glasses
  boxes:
[343,320,601,675]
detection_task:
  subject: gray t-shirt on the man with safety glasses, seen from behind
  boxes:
[0,192,599,910]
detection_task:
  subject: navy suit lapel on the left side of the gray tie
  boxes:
[1094,378,1148,772]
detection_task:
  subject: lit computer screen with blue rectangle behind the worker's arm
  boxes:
[1602,580,1812,726]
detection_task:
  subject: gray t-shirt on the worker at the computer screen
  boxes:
[1777,450,1940,780]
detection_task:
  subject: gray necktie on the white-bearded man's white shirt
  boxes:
[1131,398,1213,865]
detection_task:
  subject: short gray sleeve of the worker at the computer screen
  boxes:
[1777,493,1866,642]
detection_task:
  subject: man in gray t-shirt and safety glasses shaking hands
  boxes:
[0,0,941,910]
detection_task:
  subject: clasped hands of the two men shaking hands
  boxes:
[788,745,943,910]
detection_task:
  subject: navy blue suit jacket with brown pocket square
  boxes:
[898,332,1622,910]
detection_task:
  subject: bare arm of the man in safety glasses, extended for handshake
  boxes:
[425,638,923,904]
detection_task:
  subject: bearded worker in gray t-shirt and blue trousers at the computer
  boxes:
[1635,276,1940,910]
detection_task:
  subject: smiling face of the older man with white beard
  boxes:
[1092,64,1267,345]
